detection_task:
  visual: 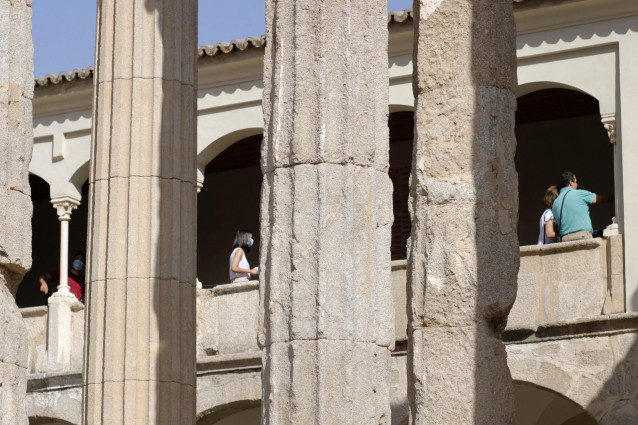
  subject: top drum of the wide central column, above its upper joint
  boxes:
[261,1,389,172]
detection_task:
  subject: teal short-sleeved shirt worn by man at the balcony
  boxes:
[552,187,596,236]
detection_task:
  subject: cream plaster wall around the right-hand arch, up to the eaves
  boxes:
[517,0,638,311]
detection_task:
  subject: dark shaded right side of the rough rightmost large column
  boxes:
[472,0,520,425]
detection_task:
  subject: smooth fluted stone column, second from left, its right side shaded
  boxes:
[83,0,197,424]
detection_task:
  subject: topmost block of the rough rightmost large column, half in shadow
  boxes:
[414,0,516,93]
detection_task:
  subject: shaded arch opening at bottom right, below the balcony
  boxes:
[514,380,598,425]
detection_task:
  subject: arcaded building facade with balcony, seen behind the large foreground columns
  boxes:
[11,0,638,425]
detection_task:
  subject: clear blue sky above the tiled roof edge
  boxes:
[33,0,412,75]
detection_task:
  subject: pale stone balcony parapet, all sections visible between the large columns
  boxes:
[21,235,624,374]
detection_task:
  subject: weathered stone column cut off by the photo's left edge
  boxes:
[0,0,34,425]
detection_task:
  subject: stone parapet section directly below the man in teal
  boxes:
[508,235,625,329]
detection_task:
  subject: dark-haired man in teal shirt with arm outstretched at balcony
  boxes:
[552,171,611,242]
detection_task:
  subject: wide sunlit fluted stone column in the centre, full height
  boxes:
[260,0,394,425]
